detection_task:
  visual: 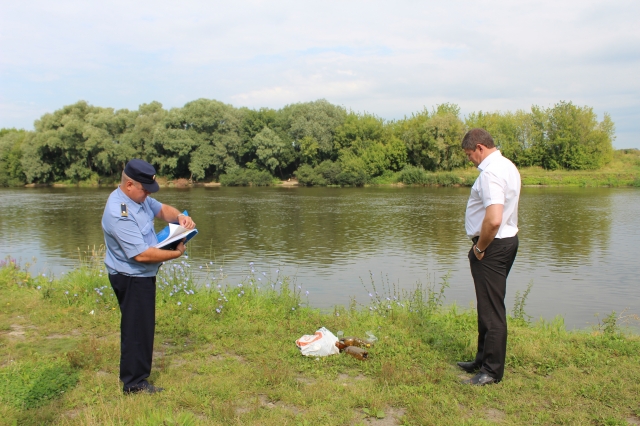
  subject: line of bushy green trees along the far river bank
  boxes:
[0,99,615,186]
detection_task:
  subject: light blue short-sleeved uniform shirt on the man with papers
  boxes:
[102,187,162,277]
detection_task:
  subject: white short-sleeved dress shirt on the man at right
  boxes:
[464,151,521,238]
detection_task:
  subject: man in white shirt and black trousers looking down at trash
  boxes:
[458,129,521,386]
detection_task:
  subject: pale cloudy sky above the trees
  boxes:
[0,0,640,148]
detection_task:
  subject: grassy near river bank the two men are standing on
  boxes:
[0,253,640,425]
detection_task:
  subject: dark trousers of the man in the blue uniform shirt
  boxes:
[109,274,156,391]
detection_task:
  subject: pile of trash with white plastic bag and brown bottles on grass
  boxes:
[296,327,378,361]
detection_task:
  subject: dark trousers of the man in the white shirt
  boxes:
[469,235,518,381]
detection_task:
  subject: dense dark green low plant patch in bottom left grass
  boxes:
[0,360,78,409]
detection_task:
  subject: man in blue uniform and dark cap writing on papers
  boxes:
[102,159,195,393]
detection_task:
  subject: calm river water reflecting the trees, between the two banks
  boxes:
[0,188,640,327]
